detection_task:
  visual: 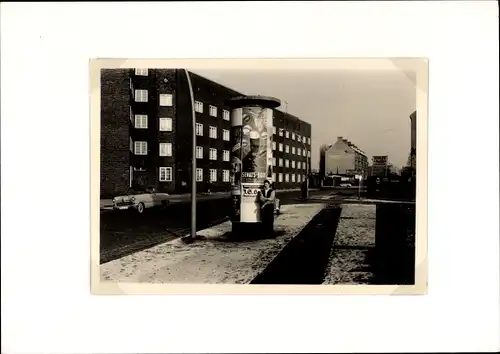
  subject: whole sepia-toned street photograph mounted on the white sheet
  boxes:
[92,58,427,292]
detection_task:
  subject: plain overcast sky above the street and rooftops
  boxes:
[193,69,416,168]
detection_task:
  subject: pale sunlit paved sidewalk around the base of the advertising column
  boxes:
[100,204,325,286]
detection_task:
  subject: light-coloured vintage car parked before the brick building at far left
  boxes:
[113,187,170,214]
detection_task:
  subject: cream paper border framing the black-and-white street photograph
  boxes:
[90,57,429,295]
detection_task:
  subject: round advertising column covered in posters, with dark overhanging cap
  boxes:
[228,96,280,224]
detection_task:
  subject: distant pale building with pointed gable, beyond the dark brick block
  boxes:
[324,136,368,176]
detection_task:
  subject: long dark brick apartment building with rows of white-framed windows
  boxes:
[100,69,311,198]
